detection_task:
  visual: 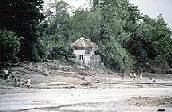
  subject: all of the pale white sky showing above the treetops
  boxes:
[44,0,172,29]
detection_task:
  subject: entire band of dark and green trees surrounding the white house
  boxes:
[0,0,172,72]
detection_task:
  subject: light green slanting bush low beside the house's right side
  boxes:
[99,39,134,72]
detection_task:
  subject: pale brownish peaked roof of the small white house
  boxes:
[72,37,97,48]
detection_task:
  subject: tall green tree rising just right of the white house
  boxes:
[90,0,135,71]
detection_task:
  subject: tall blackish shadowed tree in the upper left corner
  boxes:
[0,0,44,61]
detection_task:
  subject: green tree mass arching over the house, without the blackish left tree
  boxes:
[41,0,172,71]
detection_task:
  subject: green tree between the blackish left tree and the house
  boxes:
[42,1,74,60]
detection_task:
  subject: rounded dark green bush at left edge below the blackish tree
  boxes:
[0,30,20,63]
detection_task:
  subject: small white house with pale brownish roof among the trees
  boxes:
[72,37,101,66]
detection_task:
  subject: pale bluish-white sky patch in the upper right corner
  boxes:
[130,0,172,28]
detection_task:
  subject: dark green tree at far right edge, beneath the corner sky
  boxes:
[142,15,172,70]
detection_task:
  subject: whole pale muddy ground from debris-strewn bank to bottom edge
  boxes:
[0,61,172,112]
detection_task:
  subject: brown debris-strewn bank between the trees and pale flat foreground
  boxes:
[0,61,172,89]
